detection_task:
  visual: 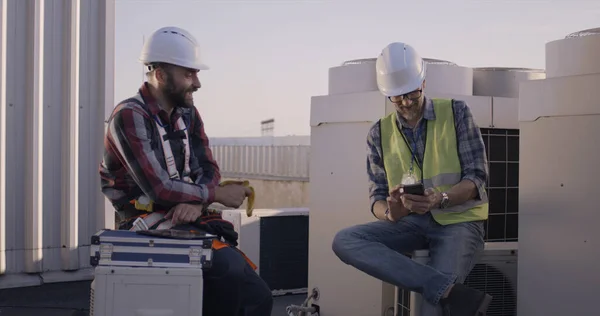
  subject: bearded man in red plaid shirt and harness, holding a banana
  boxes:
[100,27,273,316]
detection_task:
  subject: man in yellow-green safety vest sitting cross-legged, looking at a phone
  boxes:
[332,43,492,316]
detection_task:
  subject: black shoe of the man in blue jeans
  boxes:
[440,283,492,316]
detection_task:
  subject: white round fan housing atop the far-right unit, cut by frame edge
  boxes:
[546,28,600,78]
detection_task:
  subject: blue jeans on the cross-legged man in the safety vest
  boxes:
[332,213,484,315]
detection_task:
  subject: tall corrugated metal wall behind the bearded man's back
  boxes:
[0,0,115,288]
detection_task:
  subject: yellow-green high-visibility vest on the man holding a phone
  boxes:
[380,99,488,225]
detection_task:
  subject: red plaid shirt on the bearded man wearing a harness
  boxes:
[100,83,221,210]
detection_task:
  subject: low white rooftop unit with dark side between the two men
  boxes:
[222,208,308,296]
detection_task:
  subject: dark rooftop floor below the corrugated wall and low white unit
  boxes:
[0,281,305,316]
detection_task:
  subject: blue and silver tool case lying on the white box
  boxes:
[90,229,217,268]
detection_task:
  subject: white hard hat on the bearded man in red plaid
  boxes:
[140,26,209,70]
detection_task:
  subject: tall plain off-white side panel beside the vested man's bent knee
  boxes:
[308,91,394,315]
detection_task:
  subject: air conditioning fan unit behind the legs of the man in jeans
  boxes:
[394,242,518,316]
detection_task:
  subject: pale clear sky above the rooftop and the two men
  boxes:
[115,0,600,137]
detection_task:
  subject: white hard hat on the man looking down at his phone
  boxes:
[375,43,426,97]
